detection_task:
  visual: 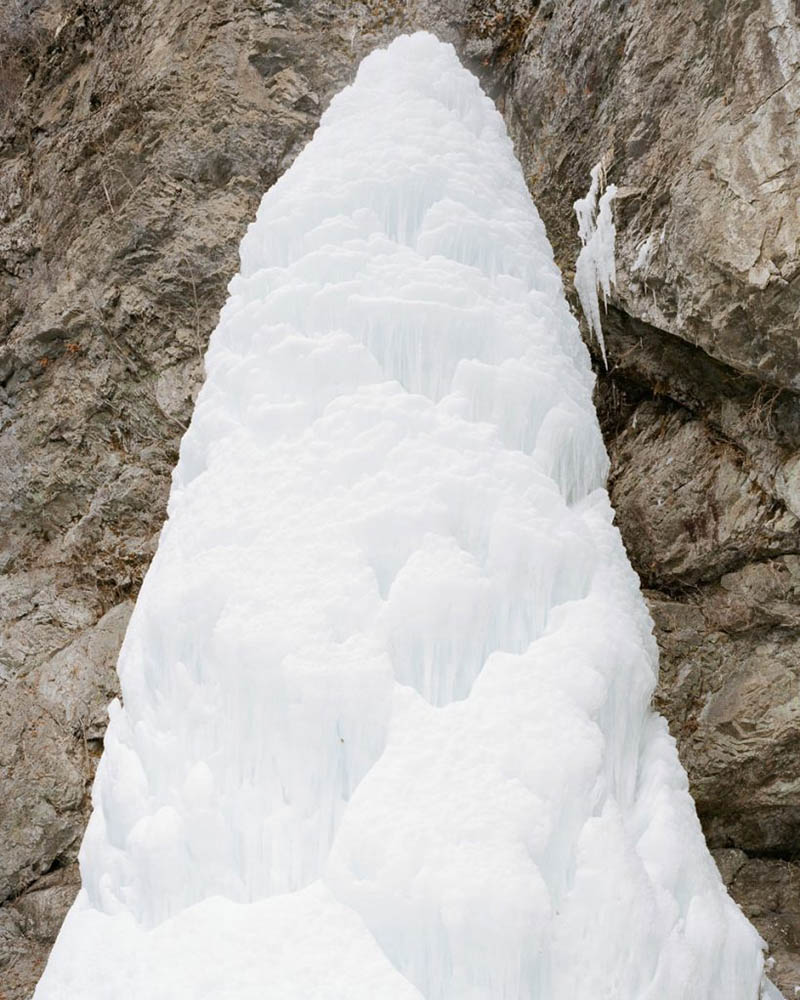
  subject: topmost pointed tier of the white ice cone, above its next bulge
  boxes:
[241,20,544,290]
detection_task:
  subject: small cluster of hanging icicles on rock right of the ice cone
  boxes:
[574,160,617,362]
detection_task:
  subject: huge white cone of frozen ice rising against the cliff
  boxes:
[36,34,762,1000]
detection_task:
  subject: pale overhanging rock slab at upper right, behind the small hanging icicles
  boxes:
[510,0,800,390]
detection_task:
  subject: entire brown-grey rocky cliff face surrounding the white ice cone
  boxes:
[0,0,800,1000]
